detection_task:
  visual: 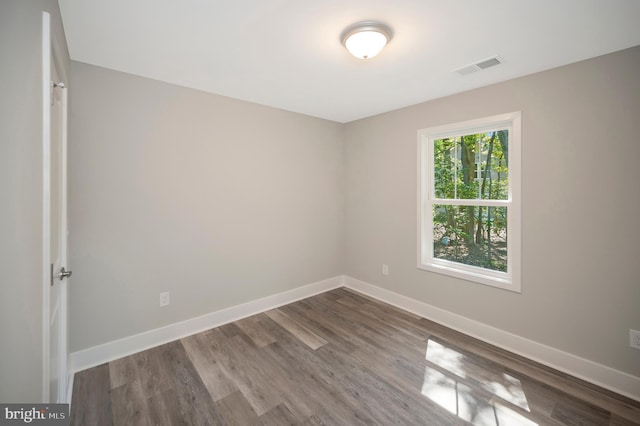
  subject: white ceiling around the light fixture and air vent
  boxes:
[59,0,640,123]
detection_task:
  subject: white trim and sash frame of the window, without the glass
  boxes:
[417,111,522,293]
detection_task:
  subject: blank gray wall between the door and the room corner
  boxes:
[69,62,344,351]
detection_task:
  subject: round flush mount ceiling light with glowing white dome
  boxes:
[342,21,391,59]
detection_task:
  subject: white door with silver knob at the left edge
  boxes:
[43,12,70,403]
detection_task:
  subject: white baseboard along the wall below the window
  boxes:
[344,276,640,401]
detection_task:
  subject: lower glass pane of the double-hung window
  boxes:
[433,204,507,272]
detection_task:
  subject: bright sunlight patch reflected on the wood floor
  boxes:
[422,339,537,426]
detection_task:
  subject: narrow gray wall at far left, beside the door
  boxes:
[0,0,69,403]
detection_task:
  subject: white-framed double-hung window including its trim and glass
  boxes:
[418,112,521,292]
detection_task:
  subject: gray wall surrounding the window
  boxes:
[345,47,640,376]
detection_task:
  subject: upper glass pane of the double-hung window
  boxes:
[433,130,509,200]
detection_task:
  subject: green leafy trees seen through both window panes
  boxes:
[433,129,509,272]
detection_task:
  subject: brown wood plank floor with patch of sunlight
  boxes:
[71,288,640,426]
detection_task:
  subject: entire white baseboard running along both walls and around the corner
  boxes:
[68,276,640,401]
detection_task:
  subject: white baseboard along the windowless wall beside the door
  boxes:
[69,276,344,374]
